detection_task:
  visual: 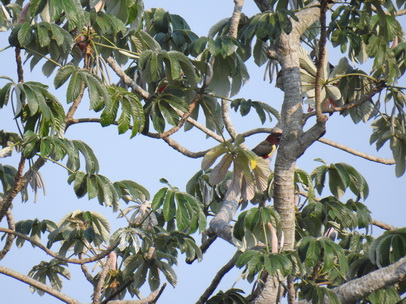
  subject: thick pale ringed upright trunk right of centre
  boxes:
[253,3,325,304]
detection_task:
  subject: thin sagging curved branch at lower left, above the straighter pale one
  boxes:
[0,227,118,265]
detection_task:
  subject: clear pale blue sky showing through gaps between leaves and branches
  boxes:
[0,0,406,304]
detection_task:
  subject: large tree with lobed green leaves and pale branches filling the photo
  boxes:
[0,0,406,304]
